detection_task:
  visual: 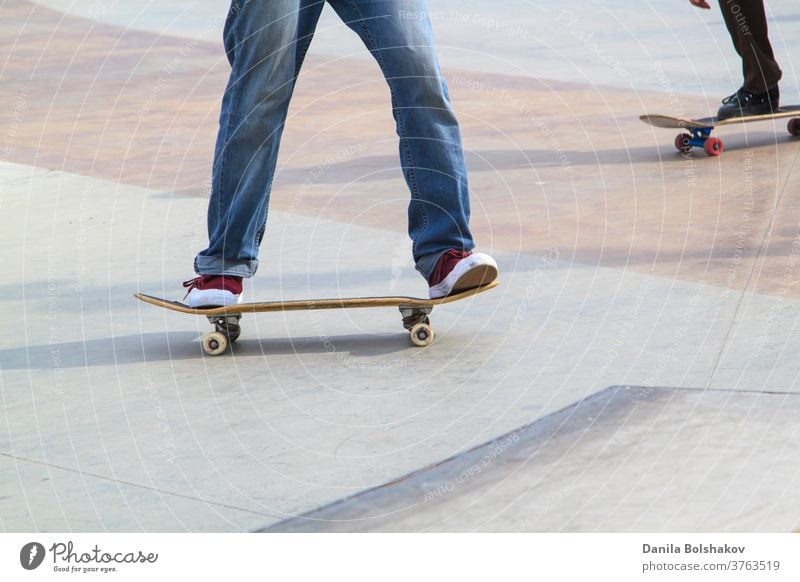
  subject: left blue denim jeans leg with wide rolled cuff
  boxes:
[195,0,324,277]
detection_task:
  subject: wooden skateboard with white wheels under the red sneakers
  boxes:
[133,281,500,356]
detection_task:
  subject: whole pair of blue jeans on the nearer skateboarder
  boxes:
[195,0,474,278]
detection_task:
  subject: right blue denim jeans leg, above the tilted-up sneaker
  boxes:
[329,0,475,278]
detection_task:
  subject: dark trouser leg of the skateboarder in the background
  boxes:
[719,0,782,93]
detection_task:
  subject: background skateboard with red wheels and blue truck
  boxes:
[639,105,800,156]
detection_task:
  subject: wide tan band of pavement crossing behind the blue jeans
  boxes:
[6,1,800,296]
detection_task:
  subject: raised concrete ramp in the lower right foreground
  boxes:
[264,386,800,532]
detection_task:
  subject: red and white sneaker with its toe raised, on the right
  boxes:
[428,249,497,299]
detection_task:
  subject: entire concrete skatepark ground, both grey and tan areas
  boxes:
[0,0,800,532]
